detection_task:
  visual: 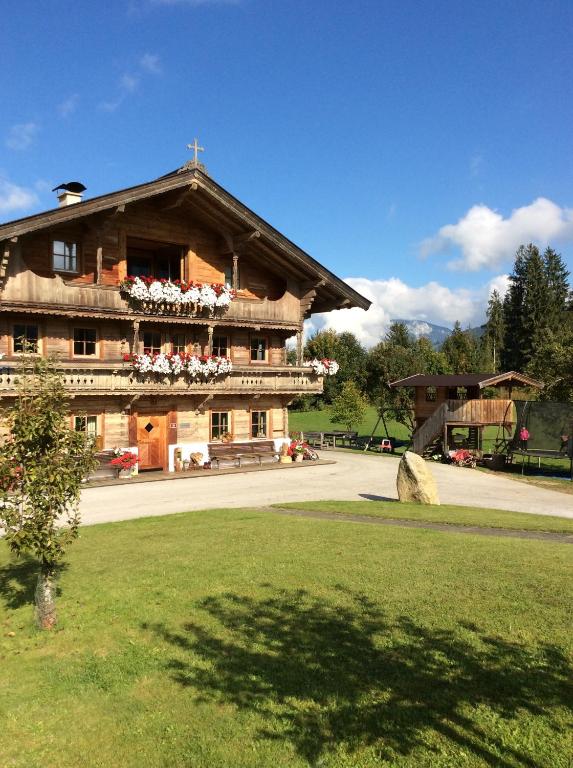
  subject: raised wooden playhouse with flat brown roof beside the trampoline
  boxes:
[390,371,543,456]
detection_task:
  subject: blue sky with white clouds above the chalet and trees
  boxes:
[0,0,573,343]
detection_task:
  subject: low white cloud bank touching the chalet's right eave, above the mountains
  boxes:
[305,275,507,347]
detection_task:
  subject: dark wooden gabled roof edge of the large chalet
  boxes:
[0,167,371,311]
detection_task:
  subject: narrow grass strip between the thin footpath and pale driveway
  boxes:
[274,501,573,534]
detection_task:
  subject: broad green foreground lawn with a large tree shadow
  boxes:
[0,505,573,768]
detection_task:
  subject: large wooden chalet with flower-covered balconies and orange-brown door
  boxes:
[0,154,370,470]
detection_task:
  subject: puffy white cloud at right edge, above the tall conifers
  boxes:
[420,197,573,271]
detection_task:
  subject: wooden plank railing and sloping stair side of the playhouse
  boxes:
[412,400,515,453]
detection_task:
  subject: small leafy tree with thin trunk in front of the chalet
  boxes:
[0,356,96,629]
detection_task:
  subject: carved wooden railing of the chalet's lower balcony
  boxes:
[0,363,323,398]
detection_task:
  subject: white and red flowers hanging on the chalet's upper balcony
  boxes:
[119,276,237,315]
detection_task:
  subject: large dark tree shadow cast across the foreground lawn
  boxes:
[146,585,573,768]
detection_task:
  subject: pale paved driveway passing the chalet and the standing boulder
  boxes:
[81,451,573,524]
